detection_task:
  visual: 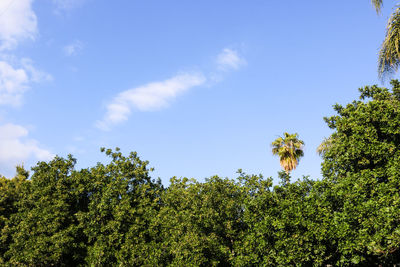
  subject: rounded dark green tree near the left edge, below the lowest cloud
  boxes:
[2,156,86,266]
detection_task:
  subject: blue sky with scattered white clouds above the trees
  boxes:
[0,0,397,185]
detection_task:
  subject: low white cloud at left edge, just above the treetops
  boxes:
[0,123,54,168]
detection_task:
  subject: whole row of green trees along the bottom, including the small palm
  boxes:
[0,80,400,266]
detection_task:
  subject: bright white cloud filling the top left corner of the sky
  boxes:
[0,0,37,51]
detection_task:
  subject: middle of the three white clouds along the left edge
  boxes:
[0,58,52,106]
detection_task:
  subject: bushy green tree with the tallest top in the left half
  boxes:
[76,148,162,266]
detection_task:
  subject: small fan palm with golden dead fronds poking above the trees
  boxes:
[271,133,304,174]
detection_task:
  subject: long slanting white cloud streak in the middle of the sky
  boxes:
[97,73,206,130]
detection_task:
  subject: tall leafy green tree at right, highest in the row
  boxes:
[322,80,400,266]
